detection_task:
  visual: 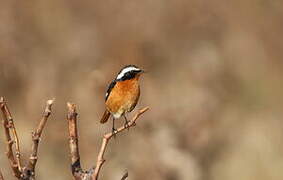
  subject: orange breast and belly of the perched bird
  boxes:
[106,78,140,117]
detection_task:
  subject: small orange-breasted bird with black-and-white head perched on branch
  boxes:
[100,65,145,133]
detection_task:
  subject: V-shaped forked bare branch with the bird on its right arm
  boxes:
[67,103,149,180]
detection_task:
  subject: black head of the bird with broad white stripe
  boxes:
[116,65,144,81]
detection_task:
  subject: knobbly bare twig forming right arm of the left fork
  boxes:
[27,99,54,175]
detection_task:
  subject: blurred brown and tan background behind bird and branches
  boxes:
[0,0,283,180]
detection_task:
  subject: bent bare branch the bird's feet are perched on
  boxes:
[92,107,149,180]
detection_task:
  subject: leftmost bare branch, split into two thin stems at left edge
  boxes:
[0,97,21,178]
